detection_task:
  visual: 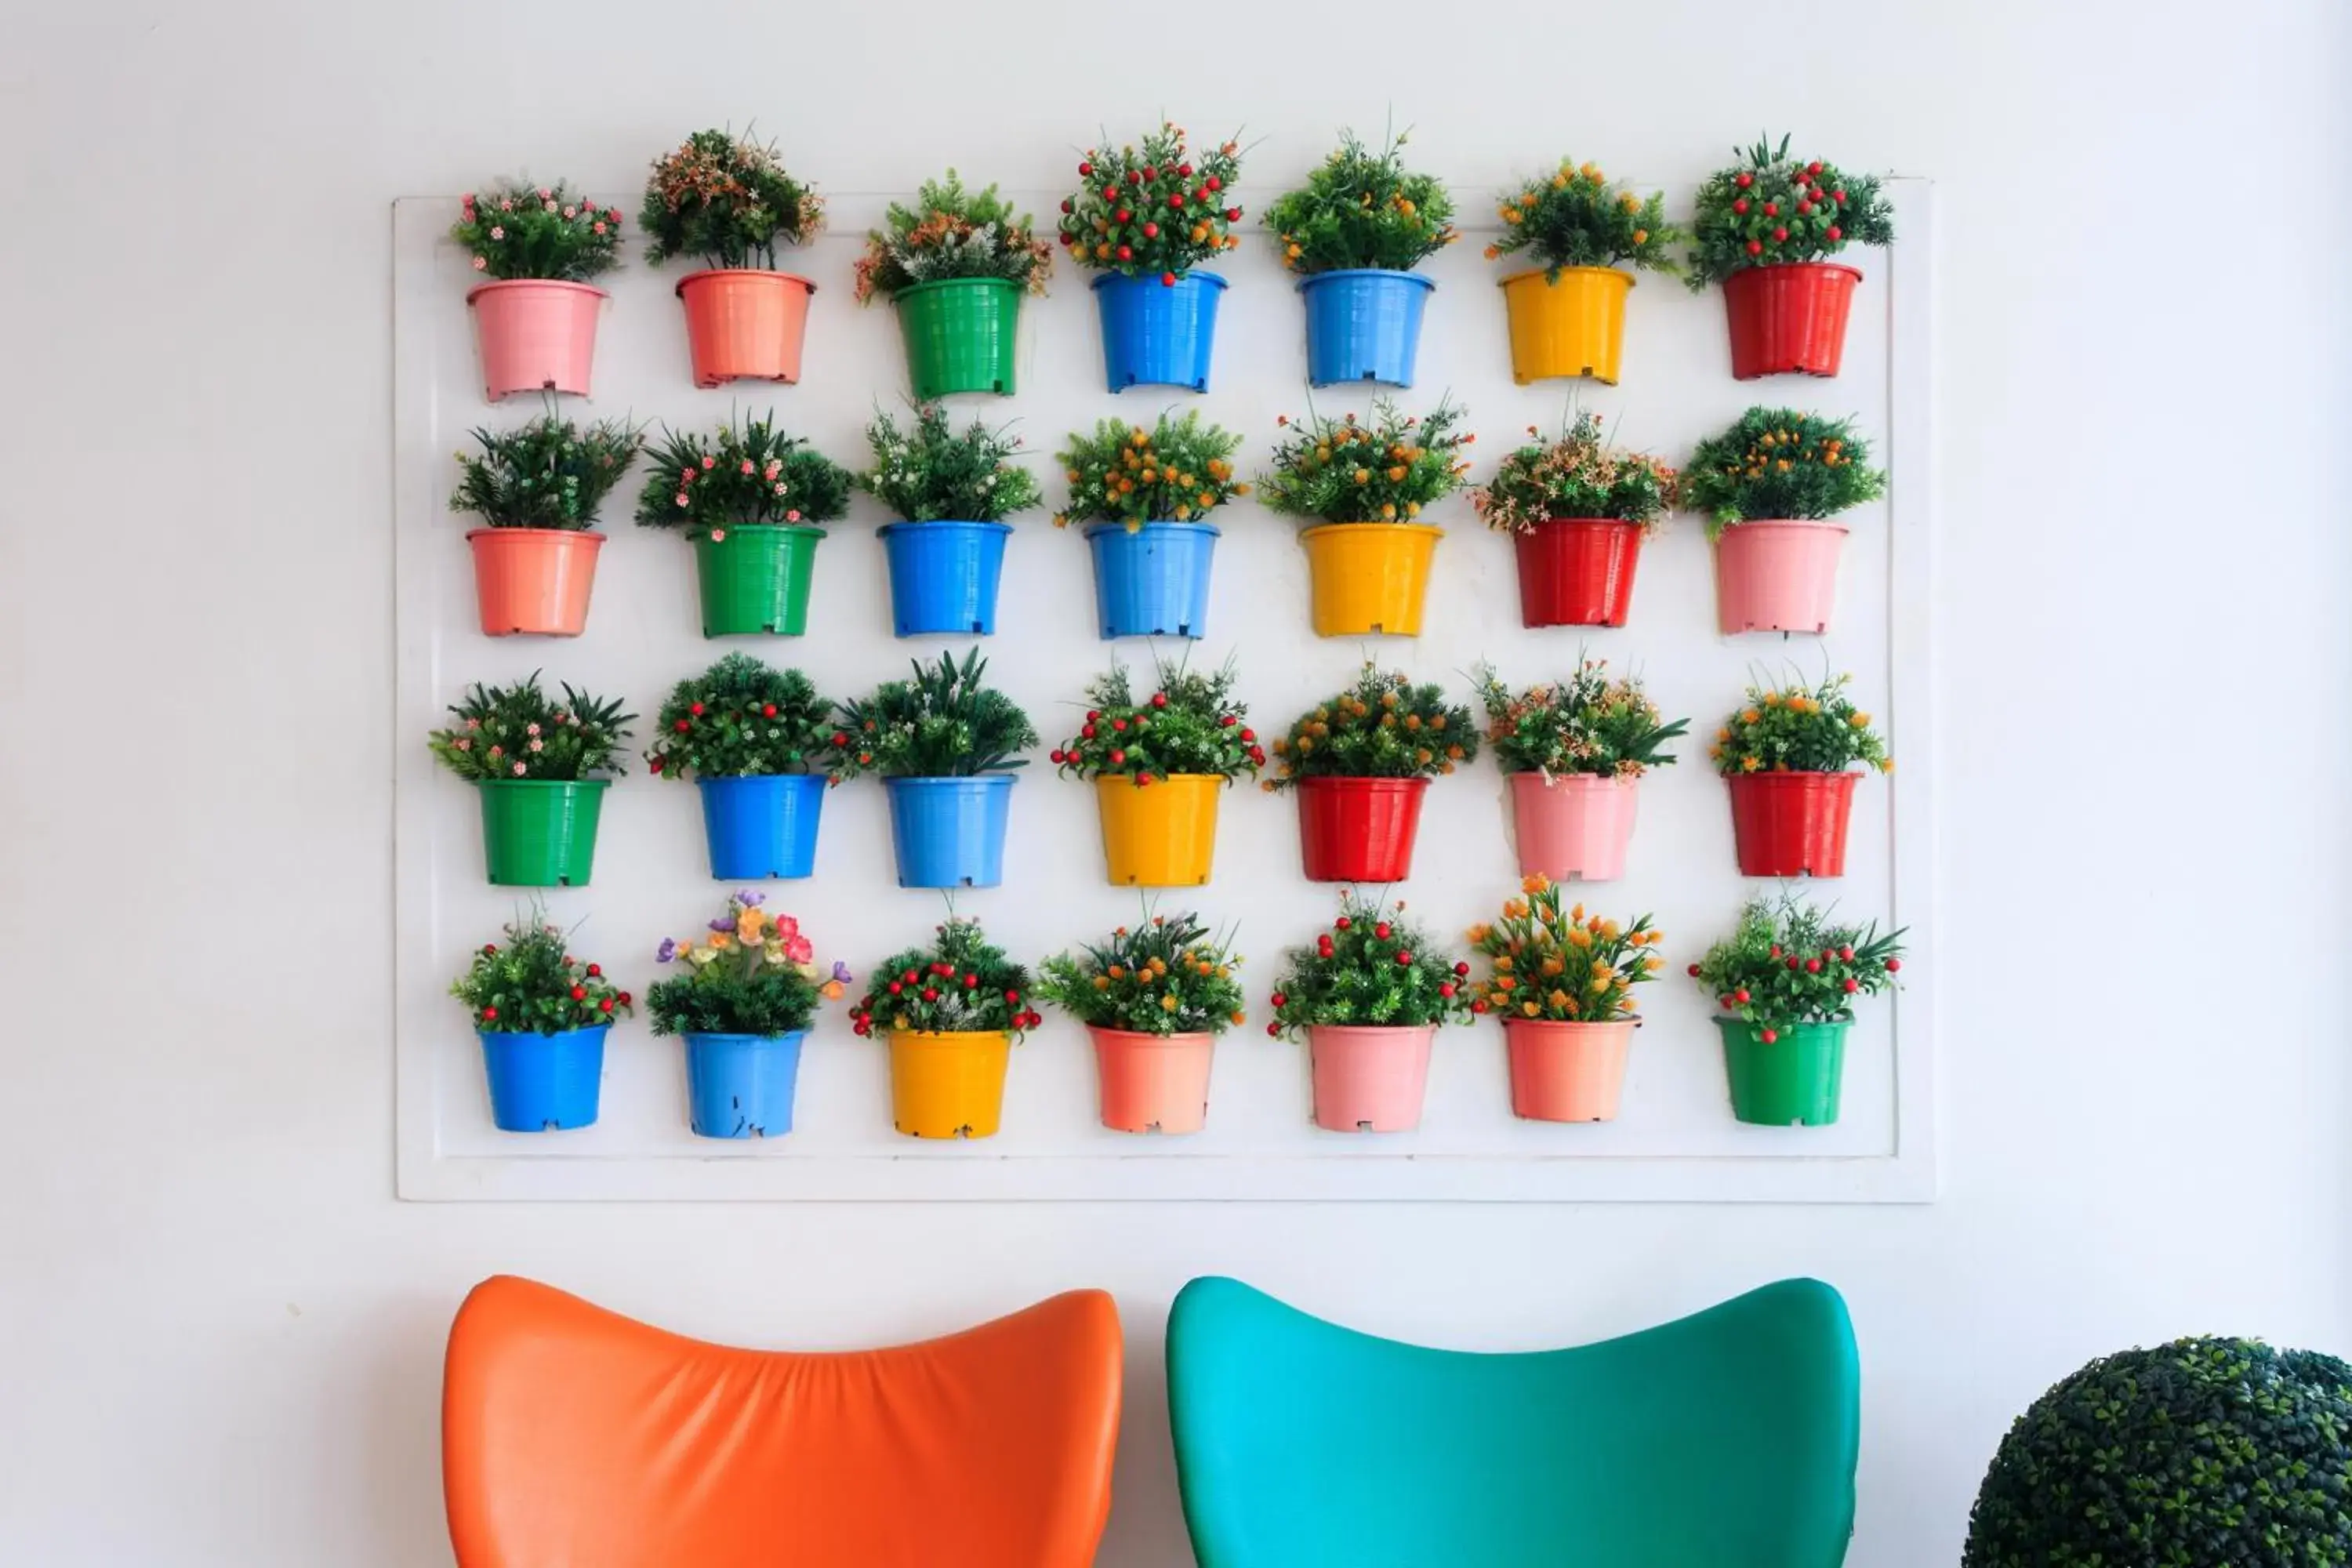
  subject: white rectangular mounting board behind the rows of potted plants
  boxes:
[393,179,1936,1201]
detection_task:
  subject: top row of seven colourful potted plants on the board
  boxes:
[452,125,1893,400]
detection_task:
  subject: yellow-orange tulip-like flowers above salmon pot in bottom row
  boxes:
[1468,877,1665,1022]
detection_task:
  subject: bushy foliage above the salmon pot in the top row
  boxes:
[637,132,826,268]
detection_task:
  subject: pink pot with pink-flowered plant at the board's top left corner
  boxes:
[449,181,621,402]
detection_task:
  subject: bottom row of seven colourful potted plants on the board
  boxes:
[452,893,1903,1138]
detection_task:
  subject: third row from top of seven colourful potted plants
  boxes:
[430,652,1893,888]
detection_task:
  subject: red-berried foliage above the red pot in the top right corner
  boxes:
[1689,136,1896,289]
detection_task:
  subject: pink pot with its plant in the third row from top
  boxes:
[1475,659,1691,881]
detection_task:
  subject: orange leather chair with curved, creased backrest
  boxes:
[442,1276,1120,1568]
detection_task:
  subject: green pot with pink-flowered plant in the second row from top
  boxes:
[637,414,851,637]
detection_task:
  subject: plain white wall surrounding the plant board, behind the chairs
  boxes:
[0,0,2352,1568]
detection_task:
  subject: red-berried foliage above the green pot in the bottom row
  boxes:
[1691,895,1903,1046]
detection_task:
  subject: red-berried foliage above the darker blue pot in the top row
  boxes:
[1061,125,1242,287]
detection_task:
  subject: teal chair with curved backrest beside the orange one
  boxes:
[1169,1279,1860,1568]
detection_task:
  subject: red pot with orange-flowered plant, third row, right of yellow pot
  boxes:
[1263,663,1477,881]
